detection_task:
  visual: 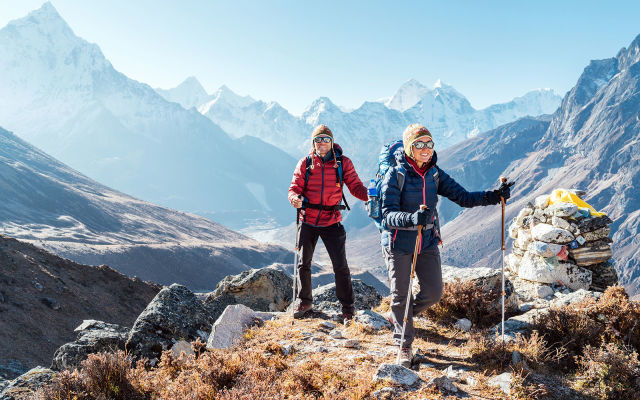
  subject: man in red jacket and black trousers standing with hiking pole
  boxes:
[289,125,367,320]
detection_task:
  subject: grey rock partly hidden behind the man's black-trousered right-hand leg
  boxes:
[313,279,382,313]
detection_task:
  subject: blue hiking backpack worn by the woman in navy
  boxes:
[365,139,439,232]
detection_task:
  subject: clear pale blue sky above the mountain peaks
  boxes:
[0,0,640,114]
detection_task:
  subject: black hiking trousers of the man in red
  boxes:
[298,222,355,314]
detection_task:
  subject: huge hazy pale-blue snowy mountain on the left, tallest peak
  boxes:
[0,3,295,227]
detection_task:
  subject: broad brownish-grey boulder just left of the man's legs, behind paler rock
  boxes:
[204,268,293,320]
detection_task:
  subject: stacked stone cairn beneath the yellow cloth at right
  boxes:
[505,191,618,300]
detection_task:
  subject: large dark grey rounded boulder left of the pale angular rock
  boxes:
[126,283,214,360]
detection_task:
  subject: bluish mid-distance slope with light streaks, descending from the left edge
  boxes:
[0,128,293,289]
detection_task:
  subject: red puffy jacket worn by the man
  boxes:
[289,144,367,226]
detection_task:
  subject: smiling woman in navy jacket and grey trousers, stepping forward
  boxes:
[381,124,512,367]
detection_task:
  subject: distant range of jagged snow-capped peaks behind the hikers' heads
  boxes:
[190,79,561,176]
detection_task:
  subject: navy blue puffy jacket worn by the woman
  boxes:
[380,148,500,253]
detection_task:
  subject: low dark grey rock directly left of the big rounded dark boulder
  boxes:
[51,319,129,371]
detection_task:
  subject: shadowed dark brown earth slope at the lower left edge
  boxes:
[0,235,160,377]
